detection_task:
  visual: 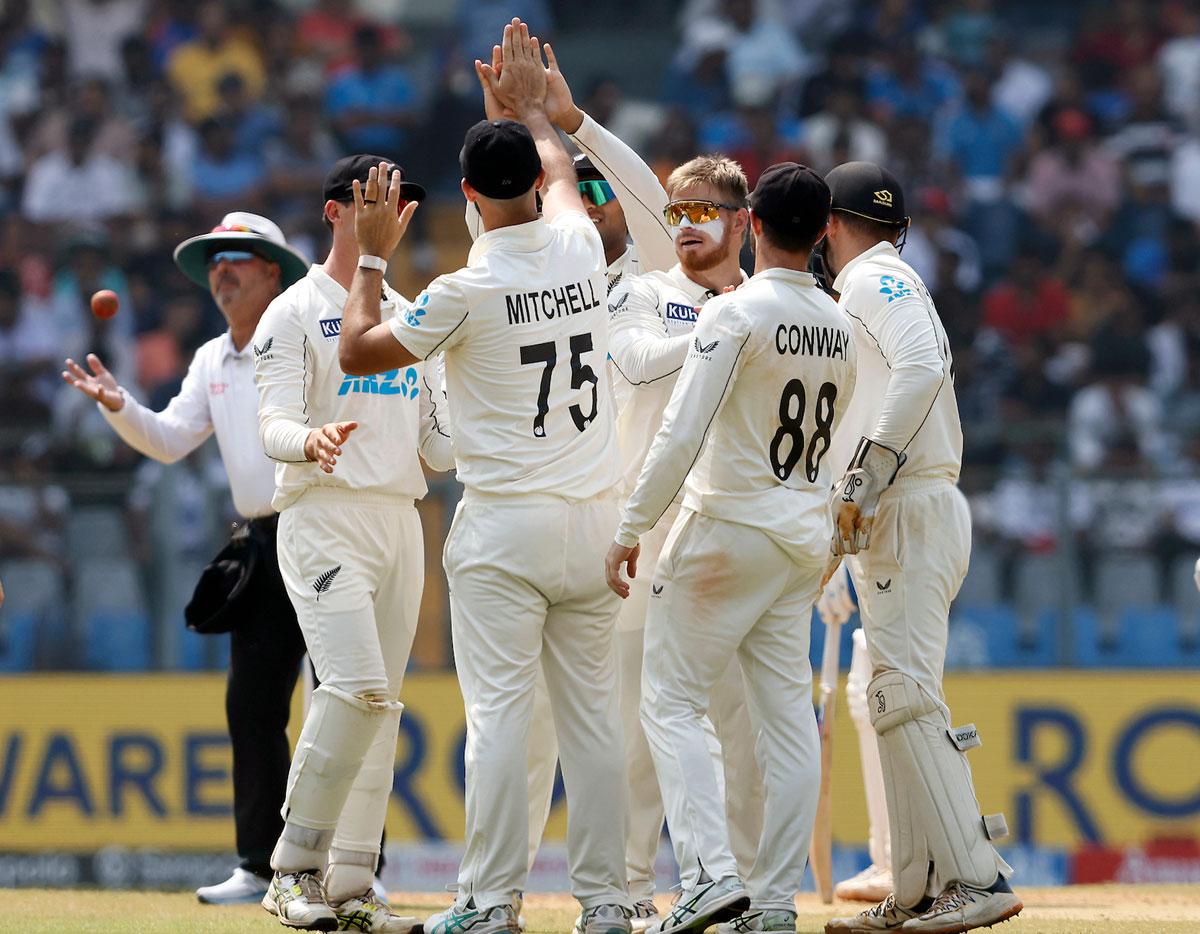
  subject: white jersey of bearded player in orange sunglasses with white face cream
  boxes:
[608,264,745,493]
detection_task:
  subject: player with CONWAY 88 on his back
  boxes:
[606,162,854,932]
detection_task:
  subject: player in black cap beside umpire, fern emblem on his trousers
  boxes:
[253,155,440,934]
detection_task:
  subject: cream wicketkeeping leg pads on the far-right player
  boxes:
[866,671,1012,908]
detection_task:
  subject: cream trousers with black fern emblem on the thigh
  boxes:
[278,489,425,884]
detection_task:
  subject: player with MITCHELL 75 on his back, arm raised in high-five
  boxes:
[341,20,631,934]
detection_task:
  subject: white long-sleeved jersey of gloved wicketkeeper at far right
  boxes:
[830,243,962,483]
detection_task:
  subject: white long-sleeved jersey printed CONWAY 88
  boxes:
[617,269,856,564]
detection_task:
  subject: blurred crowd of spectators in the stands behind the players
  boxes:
[0,0,1200,669]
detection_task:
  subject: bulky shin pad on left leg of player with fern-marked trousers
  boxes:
[271,684,404,872]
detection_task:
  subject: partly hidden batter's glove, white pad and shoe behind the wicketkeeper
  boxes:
[817,563,892,902]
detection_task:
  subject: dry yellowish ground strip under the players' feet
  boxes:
[0,885,1200,934]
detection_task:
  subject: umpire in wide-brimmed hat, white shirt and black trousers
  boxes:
[62,212,308,905]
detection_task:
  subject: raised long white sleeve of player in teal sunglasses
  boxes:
[571,114,676,276]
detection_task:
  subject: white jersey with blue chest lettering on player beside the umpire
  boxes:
[253,265,426,511]
